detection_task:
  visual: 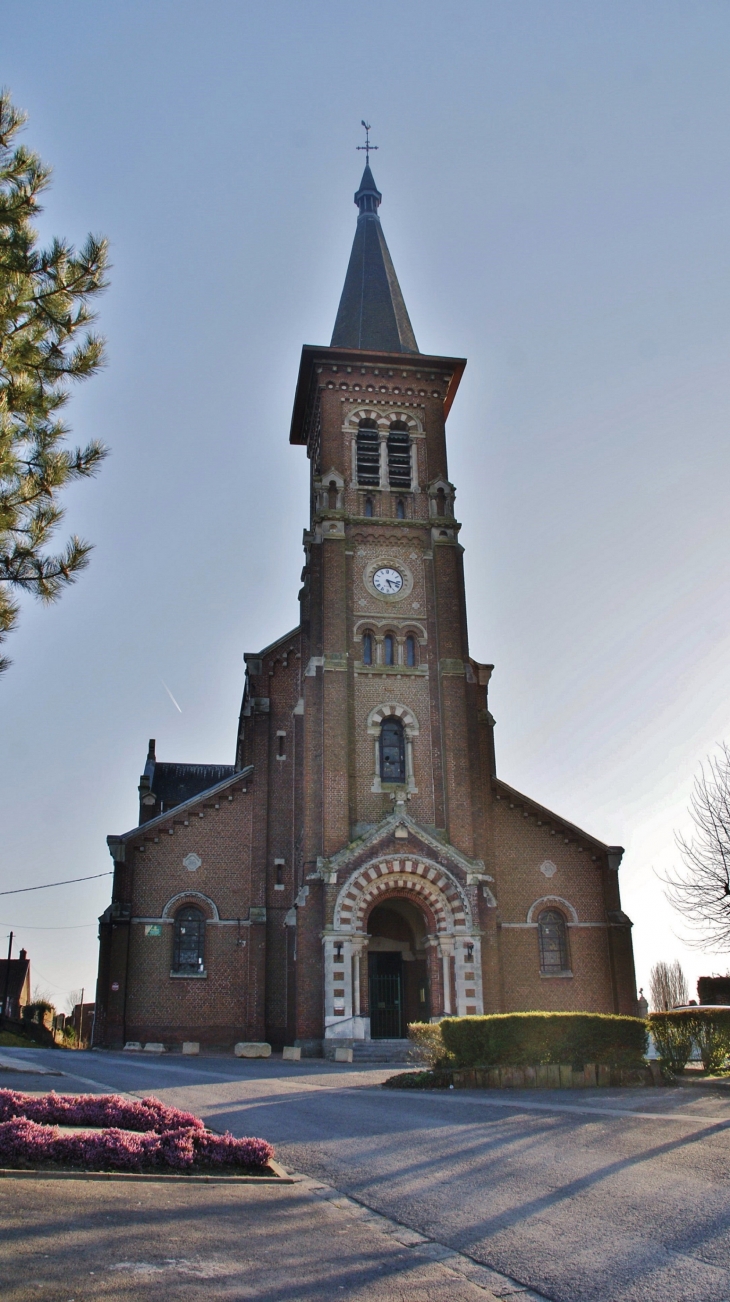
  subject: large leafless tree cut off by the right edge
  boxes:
[664,742,730,952]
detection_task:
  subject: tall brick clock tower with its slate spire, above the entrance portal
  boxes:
[284,165,492,1046]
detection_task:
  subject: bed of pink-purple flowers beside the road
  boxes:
[0,1090,273,1174]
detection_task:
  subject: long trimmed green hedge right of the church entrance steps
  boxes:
[440,1013,648,1068]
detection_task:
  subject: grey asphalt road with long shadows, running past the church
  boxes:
[0,1049,730,1302]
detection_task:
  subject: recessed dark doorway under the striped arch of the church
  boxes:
[367,897,431,1040]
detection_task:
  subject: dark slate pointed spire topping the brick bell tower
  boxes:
[331,162,418,353]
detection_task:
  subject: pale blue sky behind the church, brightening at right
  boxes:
[0,0,730,1008]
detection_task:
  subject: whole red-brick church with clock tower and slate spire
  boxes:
[94,161,636,1057]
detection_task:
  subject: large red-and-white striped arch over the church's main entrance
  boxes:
[334,857,472,935]
